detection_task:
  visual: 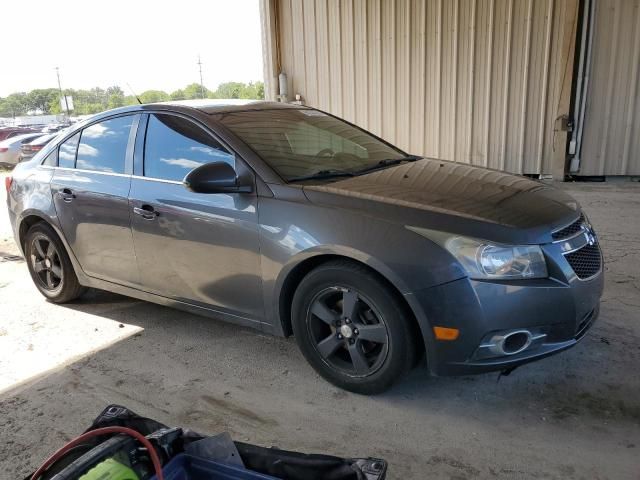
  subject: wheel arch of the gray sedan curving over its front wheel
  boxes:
[278,254,425,356]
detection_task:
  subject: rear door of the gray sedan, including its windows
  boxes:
[51,115,139,286]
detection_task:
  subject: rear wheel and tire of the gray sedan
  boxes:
[24,222,86,303]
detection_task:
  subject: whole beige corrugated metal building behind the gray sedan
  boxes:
[261,0,640,179]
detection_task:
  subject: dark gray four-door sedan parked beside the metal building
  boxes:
[7,101,603,393]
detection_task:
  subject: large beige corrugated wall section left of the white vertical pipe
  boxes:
[262,0,577,174]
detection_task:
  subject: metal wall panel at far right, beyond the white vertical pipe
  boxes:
[572,0,640,175]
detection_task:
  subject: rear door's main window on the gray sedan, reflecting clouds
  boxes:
[76,115,134,173]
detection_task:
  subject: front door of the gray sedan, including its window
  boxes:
[129,113,263,323]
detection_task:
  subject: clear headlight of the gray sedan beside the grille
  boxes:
[444,237,547,279]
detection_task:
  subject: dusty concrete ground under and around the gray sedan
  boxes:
[0,171,640,480]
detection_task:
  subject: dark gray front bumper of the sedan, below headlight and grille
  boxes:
[412,266,604,375]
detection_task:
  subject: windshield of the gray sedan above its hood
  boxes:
[220,109,405,181]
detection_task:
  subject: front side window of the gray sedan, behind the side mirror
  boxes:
[144,115,235,181]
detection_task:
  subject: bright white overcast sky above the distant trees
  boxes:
[0,0,263,97]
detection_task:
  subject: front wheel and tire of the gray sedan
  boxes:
[291,261,417,394]
